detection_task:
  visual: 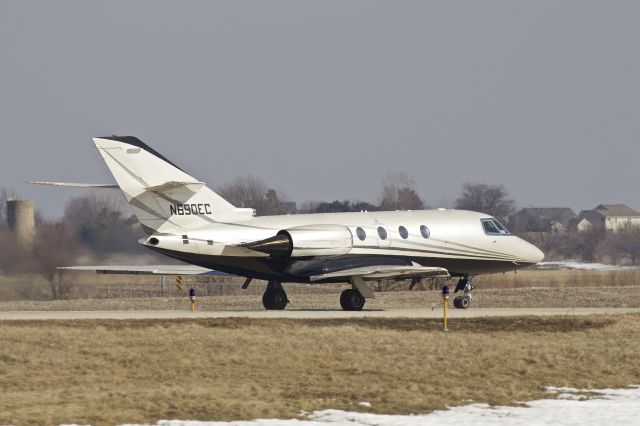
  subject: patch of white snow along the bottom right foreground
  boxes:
[121,386,640,426]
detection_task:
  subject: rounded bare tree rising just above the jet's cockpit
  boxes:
[456,183,515,222]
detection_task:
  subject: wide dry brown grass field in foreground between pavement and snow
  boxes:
[0,315,640,425]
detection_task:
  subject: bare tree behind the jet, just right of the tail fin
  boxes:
[218,175,288,216]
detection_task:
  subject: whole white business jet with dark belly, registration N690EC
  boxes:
[34,136,544,310]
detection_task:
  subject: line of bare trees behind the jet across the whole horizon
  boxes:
[0,173,640,298]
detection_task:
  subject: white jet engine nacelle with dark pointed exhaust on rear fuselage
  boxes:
[243,225,353,257]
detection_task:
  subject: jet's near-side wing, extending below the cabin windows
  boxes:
[310,263,449,281]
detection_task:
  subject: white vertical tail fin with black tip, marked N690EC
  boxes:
[93,136,253,235]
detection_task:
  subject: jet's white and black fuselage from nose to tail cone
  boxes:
[141,209,544,283]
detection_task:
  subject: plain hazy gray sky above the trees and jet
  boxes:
[0,0,640,216]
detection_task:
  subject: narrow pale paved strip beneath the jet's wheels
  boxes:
[0,308,640,321]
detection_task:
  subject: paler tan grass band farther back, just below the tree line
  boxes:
[0,269,640,301]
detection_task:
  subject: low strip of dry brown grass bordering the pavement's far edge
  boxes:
[0,284,640,311]
